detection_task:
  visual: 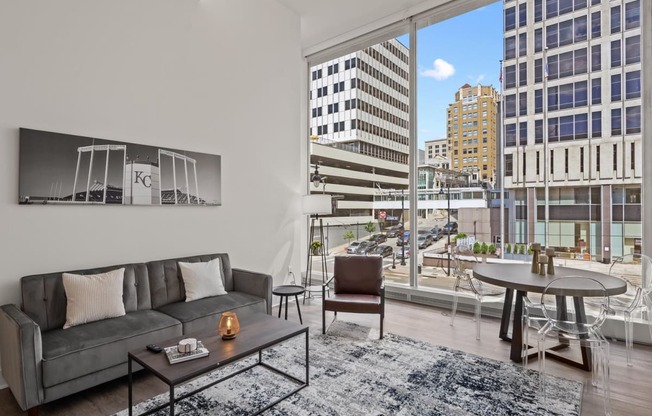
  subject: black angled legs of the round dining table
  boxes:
[499,288,592,371]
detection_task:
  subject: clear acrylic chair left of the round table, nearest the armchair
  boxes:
[450,248,505,340]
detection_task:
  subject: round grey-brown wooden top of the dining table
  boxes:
[473,264,627,297]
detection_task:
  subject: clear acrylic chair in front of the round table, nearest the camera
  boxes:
[537,276,611,415]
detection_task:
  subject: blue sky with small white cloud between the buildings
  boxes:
[398,2,503,149]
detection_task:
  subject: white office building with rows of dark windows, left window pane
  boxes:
[309,39,409,224]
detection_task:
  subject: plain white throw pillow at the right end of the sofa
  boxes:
[179,257,226,302]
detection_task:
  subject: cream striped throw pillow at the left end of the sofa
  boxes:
[63,268,125,329]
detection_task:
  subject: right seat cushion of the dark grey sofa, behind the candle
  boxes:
[158,292,267,334]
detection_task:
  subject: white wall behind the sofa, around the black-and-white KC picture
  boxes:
[0,0,305,383]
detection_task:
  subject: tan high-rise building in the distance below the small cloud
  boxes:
[446,84,499,184]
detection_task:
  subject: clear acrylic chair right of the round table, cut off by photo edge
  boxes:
[609,254,652,366]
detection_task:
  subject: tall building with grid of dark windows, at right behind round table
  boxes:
[503,0,643,261]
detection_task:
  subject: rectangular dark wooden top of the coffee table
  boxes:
[129,313,308,385]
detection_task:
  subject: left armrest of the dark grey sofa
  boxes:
[0,305,43,410]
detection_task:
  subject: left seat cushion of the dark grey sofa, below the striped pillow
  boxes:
[42,310,182,387]
